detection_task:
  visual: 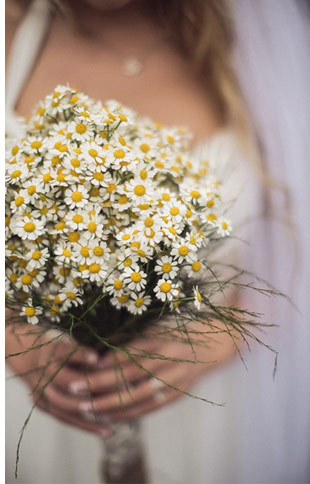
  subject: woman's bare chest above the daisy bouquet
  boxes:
[16,19,223,141]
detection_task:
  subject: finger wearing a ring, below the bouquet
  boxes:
[78,364,192,413]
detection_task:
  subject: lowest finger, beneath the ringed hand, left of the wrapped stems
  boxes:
[37,400,111,437]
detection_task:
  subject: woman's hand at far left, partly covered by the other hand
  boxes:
[6,323,111,436]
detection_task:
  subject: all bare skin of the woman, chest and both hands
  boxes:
[6,0,235,435]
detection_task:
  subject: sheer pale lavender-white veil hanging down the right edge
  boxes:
[232,0,310,483]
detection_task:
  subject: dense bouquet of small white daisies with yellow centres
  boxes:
[6,86,239,351]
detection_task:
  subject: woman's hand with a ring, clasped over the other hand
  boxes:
[31,324,235,428]
